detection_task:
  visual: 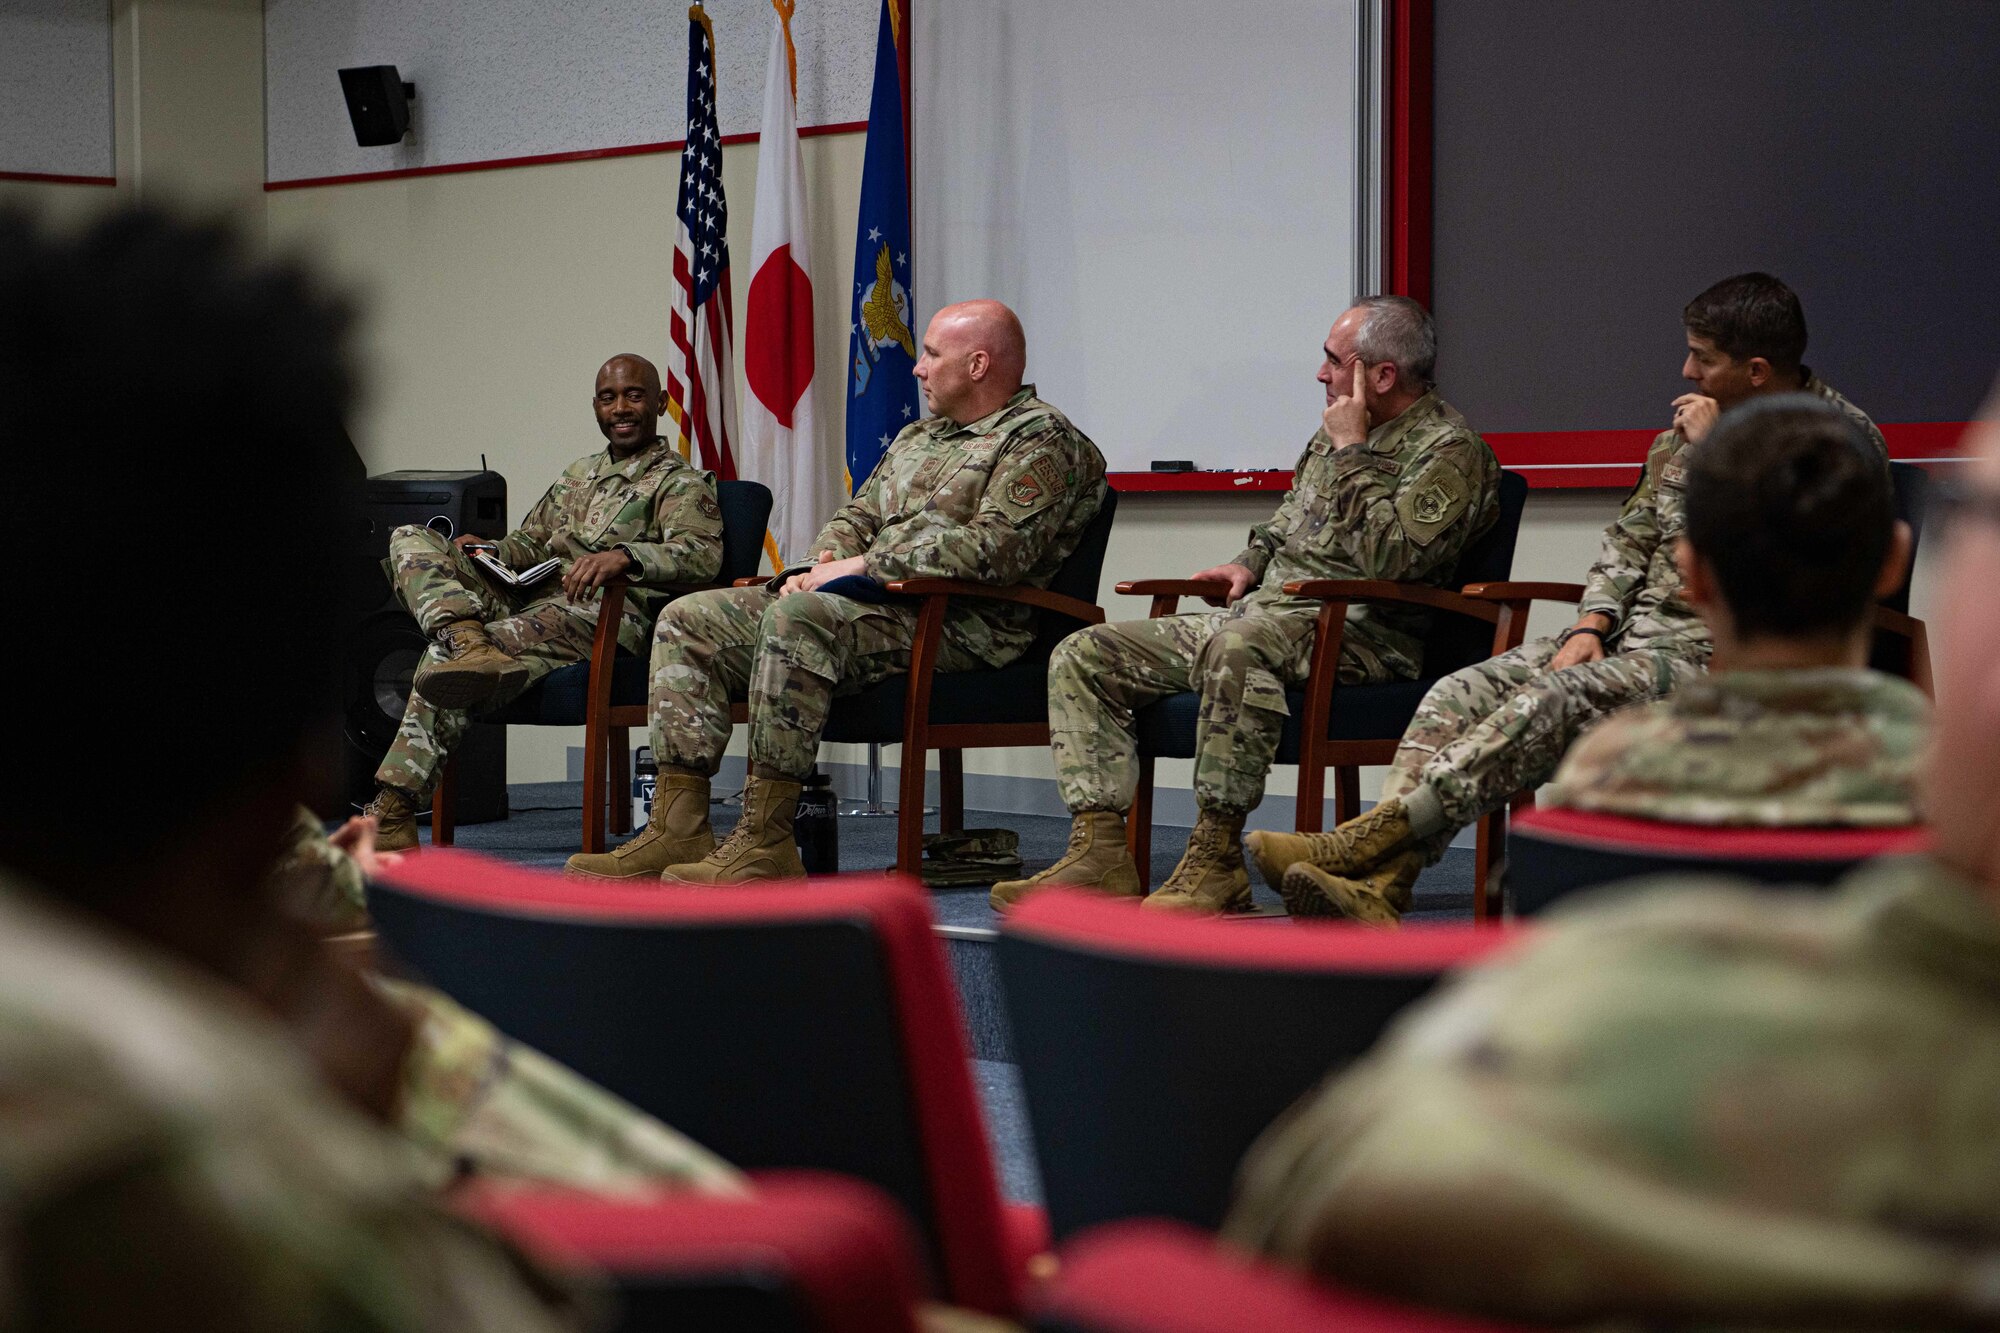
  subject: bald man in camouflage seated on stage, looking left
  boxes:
[568,300,1106,885]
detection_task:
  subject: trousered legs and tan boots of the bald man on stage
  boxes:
[566,586,986,885]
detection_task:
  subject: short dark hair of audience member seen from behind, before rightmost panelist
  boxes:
[1686,394,1896,638]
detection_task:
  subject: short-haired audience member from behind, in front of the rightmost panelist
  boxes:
[1528,394,1930,824]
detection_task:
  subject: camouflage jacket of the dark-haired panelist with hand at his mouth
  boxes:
[1576,370,1888,662]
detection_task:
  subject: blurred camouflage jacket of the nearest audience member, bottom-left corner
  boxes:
[0,877,578,1333]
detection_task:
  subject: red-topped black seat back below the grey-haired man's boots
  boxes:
[1000,889,1510,1241]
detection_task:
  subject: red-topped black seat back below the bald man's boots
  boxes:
[370,851,1018,1311]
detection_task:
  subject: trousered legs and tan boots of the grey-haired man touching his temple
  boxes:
[992,606,1360,911]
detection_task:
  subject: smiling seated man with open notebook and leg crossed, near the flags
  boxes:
[368,354,722,851]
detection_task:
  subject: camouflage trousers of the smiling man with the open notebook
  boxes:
[376,526,646,799]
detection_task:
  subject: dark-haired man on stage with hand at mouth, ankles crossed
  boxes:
[1248,272,1888,925]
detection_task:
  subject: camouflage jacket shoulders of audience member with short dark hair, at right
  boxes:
[1542,667,1930,827]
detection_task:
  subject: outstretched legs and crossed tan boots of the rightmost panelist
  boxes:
[1248,638,1700,925]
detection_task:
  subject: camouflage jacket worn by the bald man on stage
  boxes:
[812,384,1106,667]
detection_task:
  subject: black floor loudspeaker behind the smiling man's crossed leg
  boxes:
[340,472,506,825]
